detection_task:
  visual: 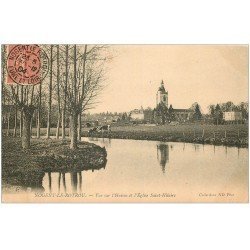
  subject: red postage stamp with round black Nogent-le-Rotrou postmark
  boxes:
[7,44,49,85]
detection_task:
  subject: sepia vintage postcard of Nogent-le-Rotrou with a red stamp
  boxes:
[1,44,249,203]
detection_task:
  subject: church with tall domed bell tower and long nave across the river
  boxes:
[156,80,194,122]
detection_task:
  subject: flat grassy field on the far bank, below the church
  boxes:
[3,124,248,147]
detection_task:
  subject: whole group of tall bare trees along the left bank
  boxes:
[2,45,109,149]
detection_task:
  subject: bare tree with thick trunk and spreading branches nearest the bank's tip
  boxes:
[60,45,106,149]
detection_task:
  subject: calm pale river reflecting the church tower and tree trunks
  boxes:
[43,138,248,202]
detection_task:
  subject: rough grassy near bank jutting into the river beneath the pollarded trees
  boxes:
[2,137,107,188]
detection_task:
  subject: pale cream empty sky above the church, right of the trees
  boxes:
[91,45,248,113]
